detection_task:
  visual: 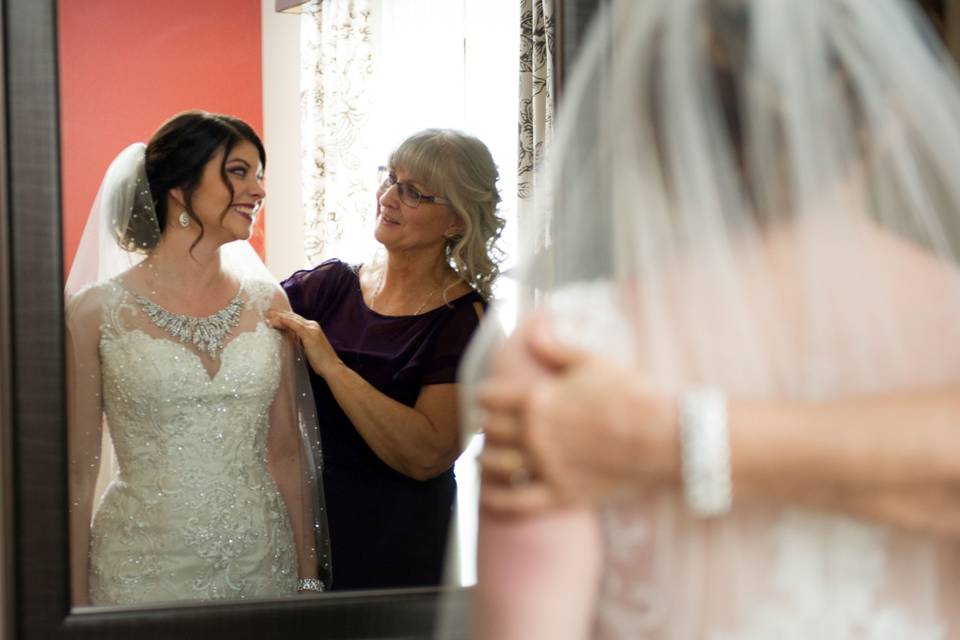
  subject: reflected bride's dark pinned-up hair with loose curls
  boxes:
[119,111,267,252]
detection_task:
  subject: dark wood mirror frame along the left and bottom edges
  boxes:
[0,0,468,640]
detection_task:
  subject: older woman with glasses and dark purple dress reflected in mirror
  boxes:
[273,129,503,589]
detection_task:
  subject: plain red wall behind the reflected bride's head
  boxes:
[58,0,264,271]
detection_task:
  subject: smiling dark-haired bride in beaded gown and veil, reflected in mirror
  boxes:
[66,111,329,605]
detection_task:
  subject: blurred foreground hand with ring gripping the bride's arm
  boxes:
[478,320,680,514]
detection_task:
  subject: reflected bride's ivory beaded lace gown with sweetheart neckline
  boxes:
[89,283,297,604]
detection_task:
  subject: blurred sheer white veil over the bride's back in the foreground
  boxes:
[463,0,960,639]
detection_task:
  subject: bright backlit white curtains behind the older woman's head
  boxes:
[301,0,519,264]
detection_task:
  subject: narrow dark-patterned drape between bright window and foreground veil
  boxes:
[517,0,556,230]
